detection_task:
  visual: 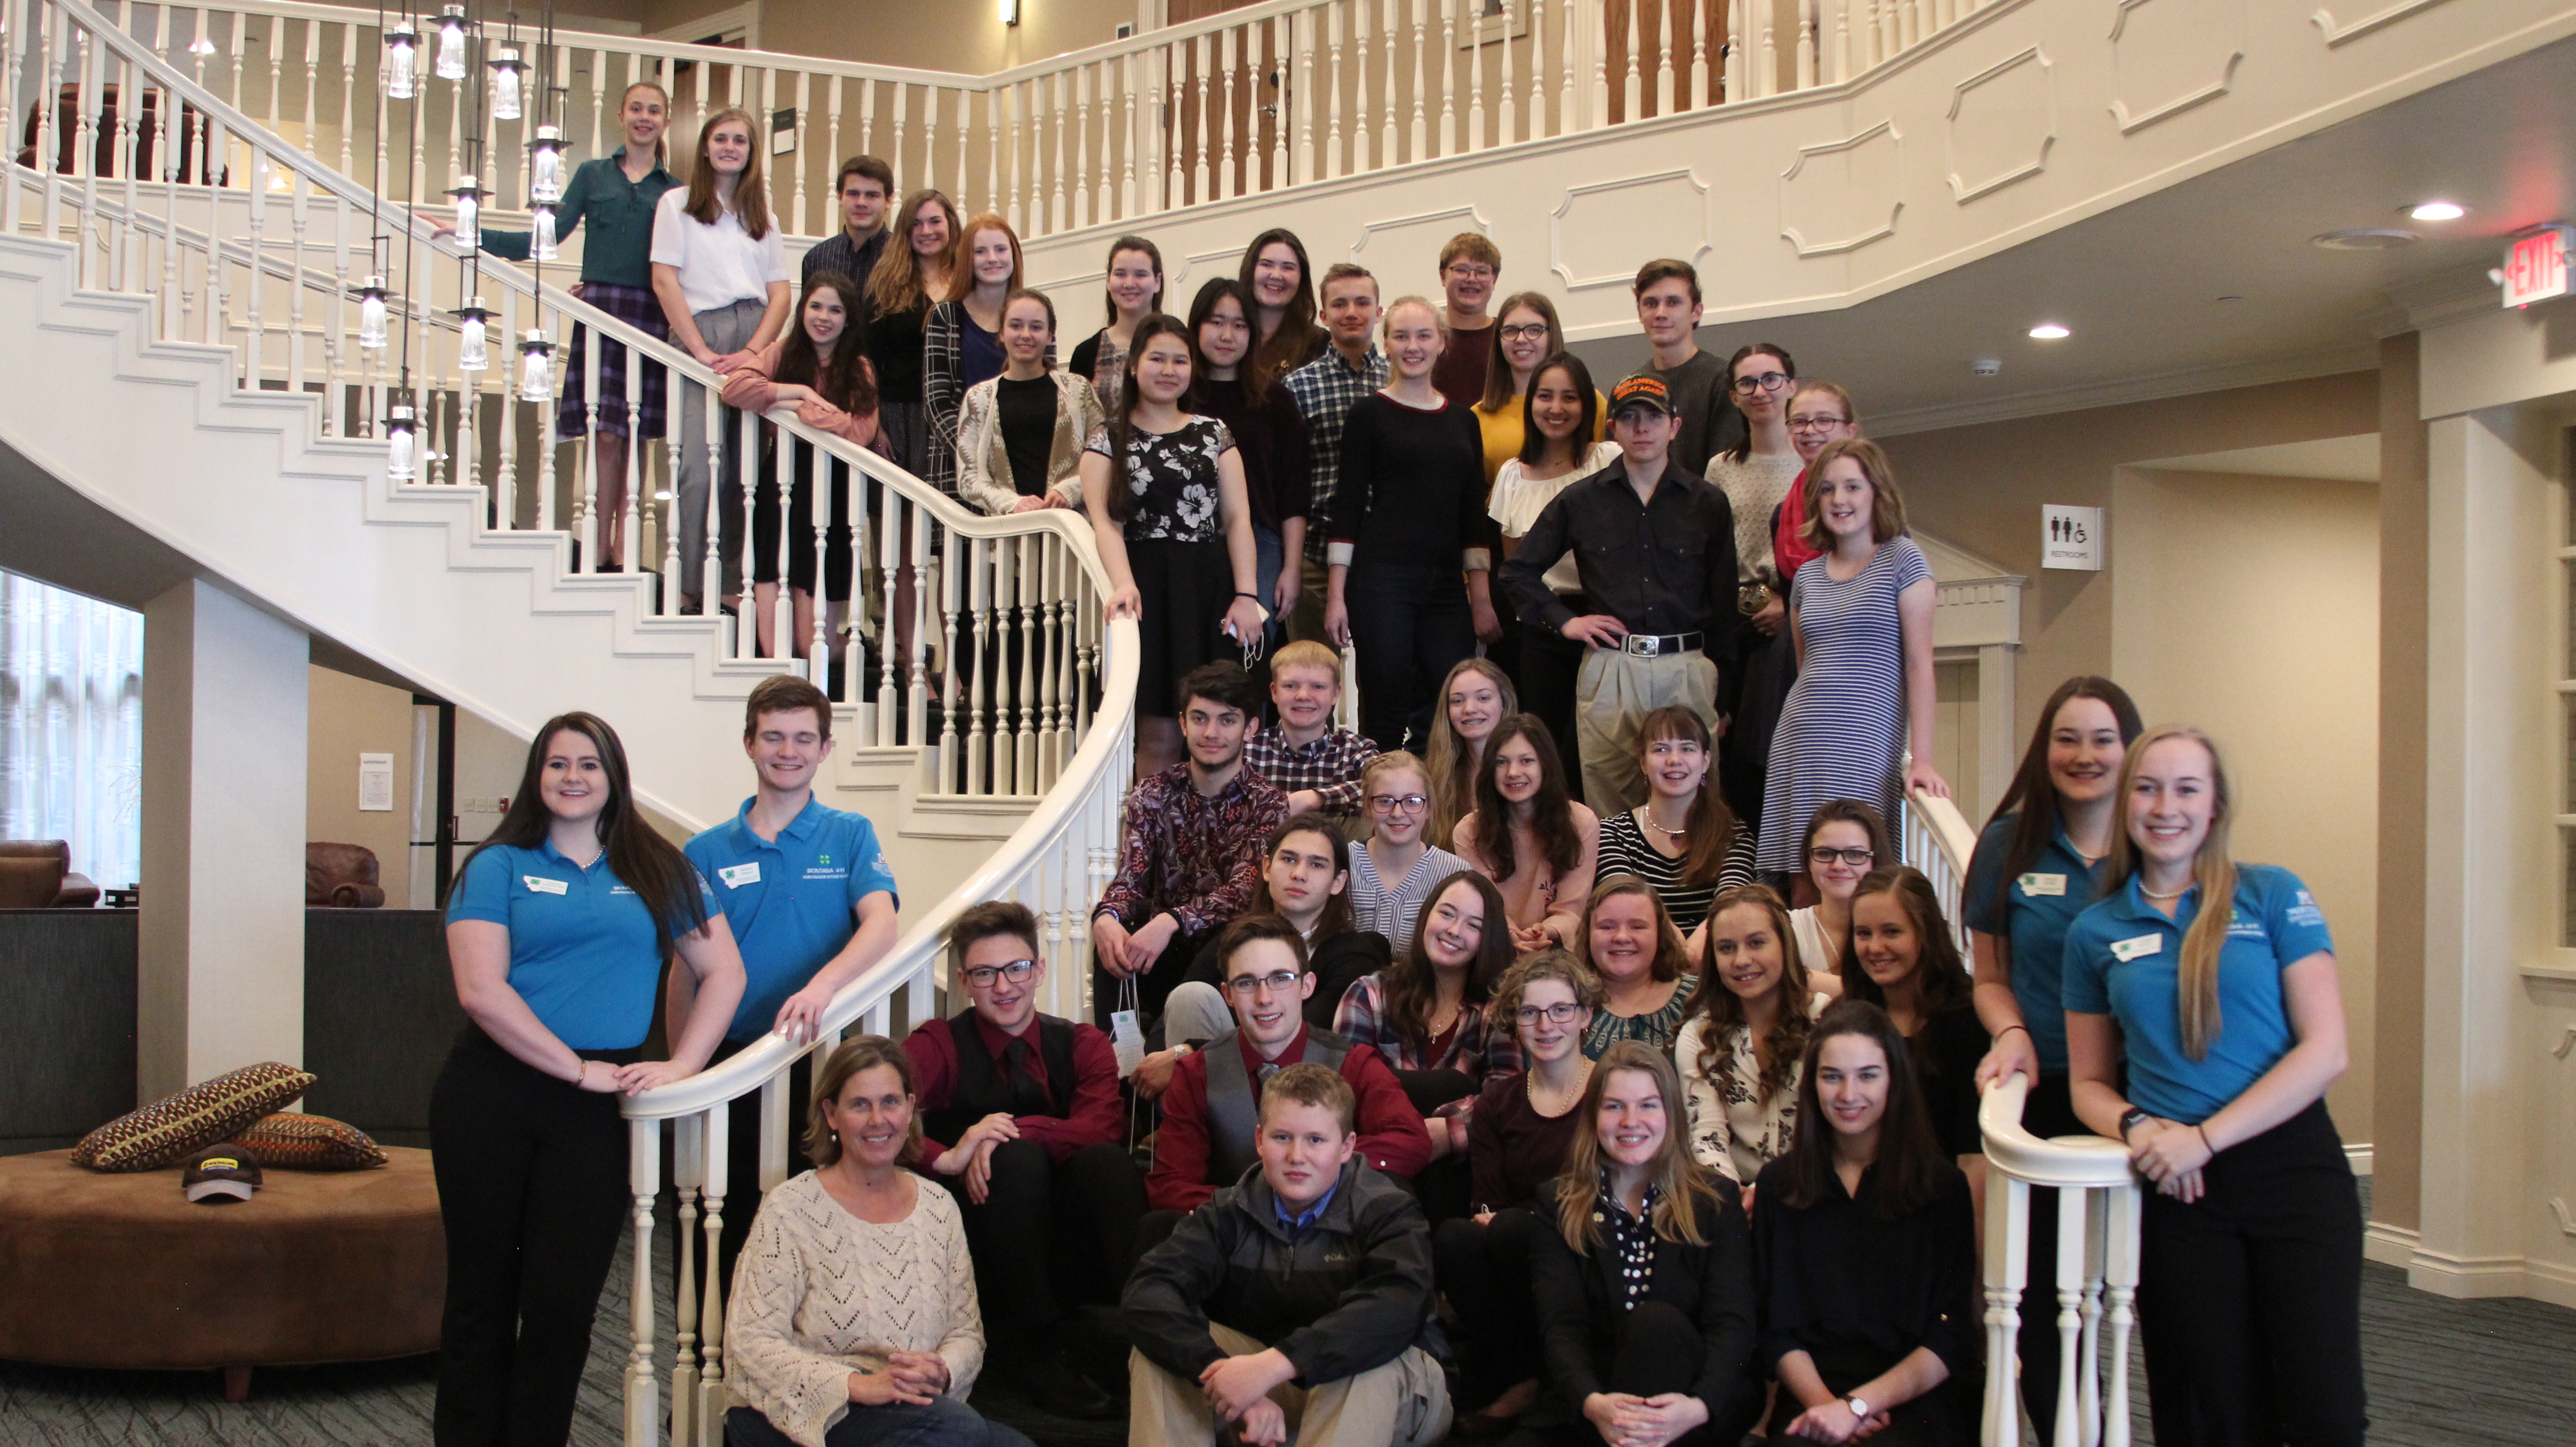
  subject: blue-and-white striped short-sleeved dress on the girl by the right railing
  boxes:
[1754,538,1932,873]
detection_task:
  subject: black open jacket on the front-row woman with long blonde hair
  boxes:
[1530,1179,1760,1442]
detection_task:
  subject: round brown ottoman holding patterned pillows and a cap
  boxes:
[0,1148,448,1393]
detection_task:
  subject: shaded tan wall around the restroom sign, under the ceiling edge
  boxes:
[1860,371,2380,736]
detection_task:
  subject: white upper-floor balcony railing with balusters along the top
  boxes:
[75,0,1994,237]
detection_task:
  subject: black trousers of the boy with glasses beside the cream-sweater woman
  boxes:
[951,1140,1144,1362]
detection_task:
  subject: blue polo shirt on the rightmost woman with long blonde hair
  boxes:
[2063,865,2334,1125]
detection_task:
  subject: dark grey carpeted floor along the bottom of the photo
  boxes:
[0,1184,2576,1447]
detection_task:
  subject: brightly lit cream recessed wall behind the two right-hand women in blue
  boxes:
[2112,469,2380,1140]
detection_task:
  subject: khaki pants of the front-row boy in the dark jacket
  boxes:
[1128,1321,1450,1447]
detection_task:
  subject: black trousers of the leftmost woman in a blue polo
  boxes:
[430,1025,639,1447]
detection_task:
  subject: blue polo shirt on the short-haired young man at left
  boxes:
[685,798,894,1040]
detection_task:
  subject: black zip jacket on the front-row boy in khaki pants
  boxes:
[1121,1156,1438,1388]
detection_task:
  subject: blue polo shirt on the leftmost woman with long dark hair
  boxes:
[448,839,714,1050]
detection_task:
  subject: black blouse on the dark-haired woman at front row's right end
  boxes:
[1752,1156,1978,1445]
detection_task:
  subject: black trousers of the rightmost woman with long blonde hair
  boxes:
[2138,1102,2367,1447]
